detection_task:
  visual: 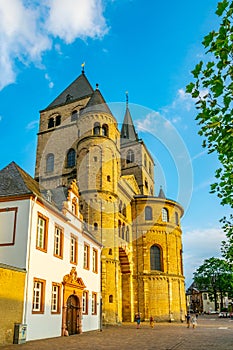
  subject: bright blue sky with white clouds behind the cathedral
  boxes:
[0,0,229,285]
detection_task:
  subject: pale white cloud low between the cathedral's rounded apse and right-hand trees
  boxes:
[183,228,225,287]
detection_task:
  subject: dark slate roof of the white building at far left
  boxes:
[0,162,40,197]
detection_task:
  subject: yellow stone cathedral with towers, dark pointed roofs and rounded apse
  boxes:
[35,69,186,324]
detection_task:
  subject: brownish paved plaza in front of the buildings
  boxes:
[0,315,233,350]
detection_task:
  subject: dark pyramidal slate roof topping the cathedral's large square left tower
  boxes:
[46,72,94,109]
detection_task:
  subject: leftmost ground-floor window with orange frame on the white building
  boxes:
[32,278,46,314]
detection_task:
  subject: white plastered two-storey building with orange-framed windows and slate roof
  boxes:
[0,162,101,340]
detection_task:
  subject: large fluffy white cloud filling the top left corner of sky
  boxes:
[0,0,107,90]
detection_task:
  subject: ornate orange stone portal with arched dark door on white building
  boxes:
[62,267,85,335]
